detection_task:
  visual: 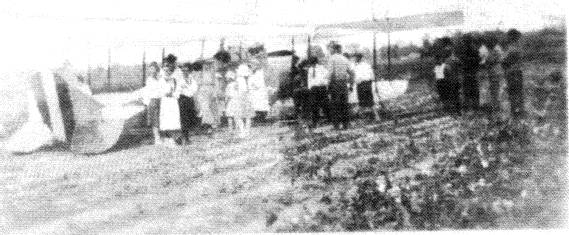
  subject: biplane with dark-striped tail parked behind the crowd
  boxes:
[1,11,464,154]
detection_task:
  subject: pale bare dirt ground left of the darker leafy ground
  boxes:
[0,126,292,234]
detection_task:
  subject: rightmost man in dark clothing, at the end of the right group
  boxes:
[502,29,524,119]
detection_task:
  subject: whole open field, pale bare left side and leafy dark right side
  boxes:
[0,28,568,234]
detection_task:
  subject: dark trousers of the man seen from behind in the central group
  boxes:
[329,81,350,128]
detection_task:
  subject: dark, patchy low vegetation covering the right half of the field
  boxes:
[267,57,567,232]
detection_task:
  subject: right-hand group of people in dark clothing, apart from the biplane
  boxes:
[434,29,524,119]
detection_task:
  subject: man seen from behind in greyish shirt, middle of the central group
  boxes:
[328,43,355,130]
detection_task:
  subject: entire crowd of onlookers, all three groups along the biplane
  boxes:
[136,29,524,144]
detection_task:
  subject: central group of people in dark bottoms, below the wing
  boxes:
[293,42,378,129]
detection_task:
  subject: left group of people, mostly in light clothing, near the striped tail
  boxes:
[141,44,269,144]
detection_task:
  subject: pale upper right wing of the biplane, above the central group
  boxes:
[315,11,464,32]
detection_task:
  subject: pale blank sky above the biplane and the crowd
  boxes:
[0,0,567,73]
